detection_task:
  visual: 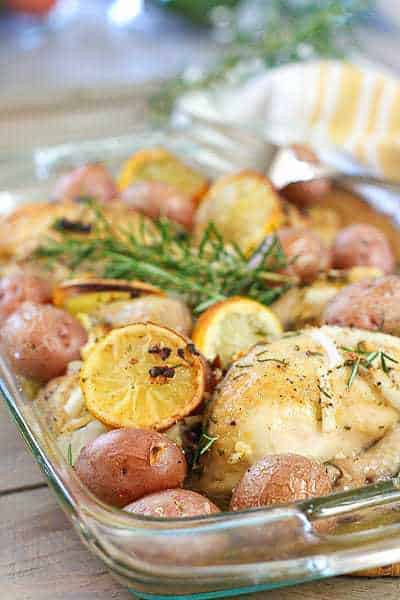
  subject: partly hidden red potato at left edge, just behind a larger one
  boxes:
[0,272,52,321]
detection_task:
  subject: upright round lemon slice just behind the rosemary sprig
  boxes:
[194,171,285,253]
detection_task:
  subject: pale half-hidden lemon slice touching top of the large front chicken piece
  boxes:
[193,296,283,367]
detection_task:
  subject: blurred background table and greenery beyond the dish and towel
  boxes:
[0,0,400,153]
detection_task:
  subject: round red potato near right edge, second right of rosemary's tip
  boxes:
[332,223,395,273]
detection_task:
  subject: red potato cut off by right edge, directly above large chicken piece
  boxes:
[323,275,400,336]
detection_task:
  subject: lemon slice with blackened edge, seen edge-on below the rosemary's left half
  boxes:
[53,277,164,315]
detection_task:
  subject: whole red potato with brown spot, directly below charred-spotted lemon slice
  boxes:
[75,429,187,508]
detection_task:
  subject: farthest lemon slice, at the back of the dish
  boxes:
[118,148,208,200]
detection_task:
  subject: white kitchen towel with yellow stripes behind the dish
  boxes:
[182,61,400,181]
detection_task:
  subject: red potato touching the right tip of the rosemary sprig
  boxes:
[278,227,331,283]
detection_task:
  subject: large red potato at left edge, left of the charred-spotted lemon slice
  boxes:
[1,302,87,381]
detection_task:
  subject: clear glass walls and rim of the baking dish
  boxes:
[0,129,400,598]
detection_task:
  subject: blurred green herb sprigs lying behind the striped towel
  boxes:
[151,0,376,118]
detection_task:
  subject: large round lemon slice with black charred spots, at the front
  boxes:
[81,323,206,431]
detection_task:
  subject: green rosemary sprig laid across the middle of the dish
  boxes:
[36,204,291,313]
